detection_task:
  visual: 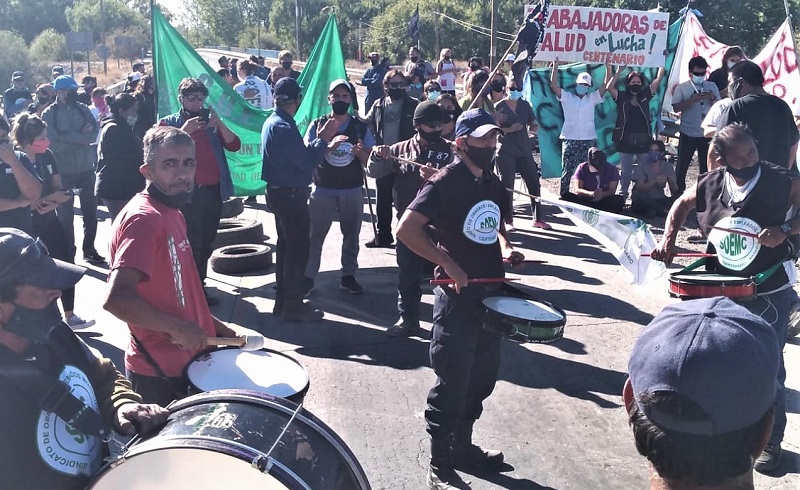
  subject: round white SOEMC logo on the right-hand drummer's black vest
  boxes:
[708,217,761,271]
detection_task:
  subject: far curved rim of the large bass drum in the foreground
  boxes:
[169,389,372,490]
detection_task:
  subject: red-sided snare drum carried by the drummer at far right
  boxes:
[669,271,757,300]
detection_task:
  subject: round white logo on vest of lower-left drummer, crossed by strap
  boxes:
[36,365,103,476]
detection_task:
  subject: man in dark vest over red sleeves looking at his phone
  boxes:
[158,78,242,306]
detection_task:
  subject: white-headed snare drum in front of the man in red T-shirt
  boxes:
[185,347,308,403]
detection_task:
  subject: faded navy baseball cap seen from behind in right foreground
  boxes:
[628,297,781,436]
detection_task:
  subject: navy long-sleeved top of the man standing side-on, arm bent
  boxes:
[261,108,328,187]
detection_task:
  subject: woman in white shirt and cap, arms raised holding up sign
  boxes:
[550,59,611,196]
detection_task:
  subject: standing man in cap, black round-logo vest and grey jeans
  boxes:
[303,78,375,294]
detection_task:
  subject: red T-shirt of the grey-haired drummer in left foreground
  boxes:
[110,192,216,376]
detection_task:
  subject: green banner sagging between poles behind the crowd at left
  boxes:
[152,7,346,196]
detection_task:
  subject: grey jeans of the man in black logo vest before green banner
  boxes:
[306,187,364,279]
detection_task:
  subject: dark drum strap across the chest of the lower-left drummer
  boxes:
[0,356,112,441]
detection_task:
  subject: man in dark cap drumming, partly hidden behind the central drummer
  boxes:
[367,101,454,337]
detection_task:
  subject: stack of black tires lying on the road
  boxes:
[211,198,274,276]
